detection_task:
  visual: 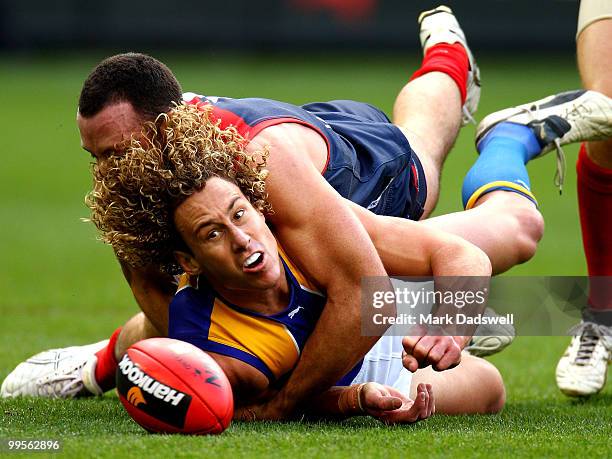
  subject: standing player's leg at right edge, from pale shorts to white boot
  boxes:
[555,9,612,396]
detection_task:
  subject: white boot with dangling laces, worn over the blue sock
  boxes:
[476,90,612,188]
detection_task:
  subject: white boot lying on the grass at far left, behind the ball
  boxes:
[0,340,108,398]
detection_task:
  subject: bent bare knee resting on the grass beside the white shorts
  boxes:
[410,354,506,414]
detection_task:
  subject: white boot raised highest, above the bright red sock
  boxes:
[419,6,480,125]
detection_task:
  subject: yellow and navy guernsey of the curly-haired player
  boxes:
[168,248,361,385]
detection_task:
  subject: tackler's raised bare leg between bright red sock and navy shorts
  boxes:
[393,72,461,218]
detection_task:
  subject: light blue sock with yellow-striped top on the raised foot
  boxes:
[461,122,542,210]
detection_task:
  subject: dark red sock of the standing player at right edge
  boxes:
[576,144,612,310]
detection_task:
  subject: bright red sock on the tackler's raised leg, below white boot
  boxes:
[410,43,470,103]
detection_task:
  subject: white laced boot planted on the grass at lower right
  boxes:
[556,322,612,397]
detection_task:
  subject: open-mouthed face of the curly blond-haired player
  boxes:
[174,177,283,291]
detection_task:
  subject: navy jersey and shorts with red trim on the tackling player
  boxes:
[183,93,427,220]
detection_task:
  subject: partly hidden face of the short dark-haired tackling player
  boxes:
[77,102,142,162]
